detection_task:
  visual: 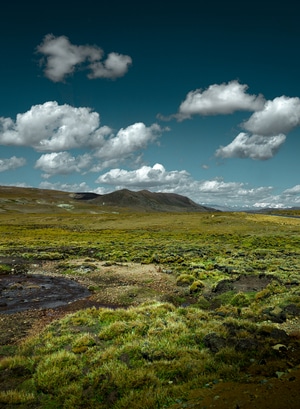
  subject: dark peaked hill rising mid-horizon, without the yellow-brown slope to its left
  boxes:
[72,189,216,212]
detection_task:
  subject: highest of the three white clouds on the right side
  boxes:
[166,81,265,120]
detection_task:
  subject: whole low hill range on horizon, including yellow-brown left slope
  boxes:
[0,186,219,214]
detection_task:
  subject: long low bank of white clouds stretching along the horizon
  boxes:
[34,156,300,209]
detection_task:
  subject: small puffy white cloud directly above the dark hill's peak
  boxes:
[96,163,190,188]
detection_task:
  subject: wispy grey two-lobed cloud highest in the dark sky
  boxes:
[37,34,132,82]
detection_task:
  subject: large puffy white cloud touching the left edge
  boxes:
[0,101,111,152]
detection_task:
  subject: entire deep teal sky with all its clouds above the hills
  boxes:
[0,0,300,210]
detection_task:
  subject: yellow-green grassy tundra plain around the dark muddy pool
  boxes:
[0,206,300,409]
